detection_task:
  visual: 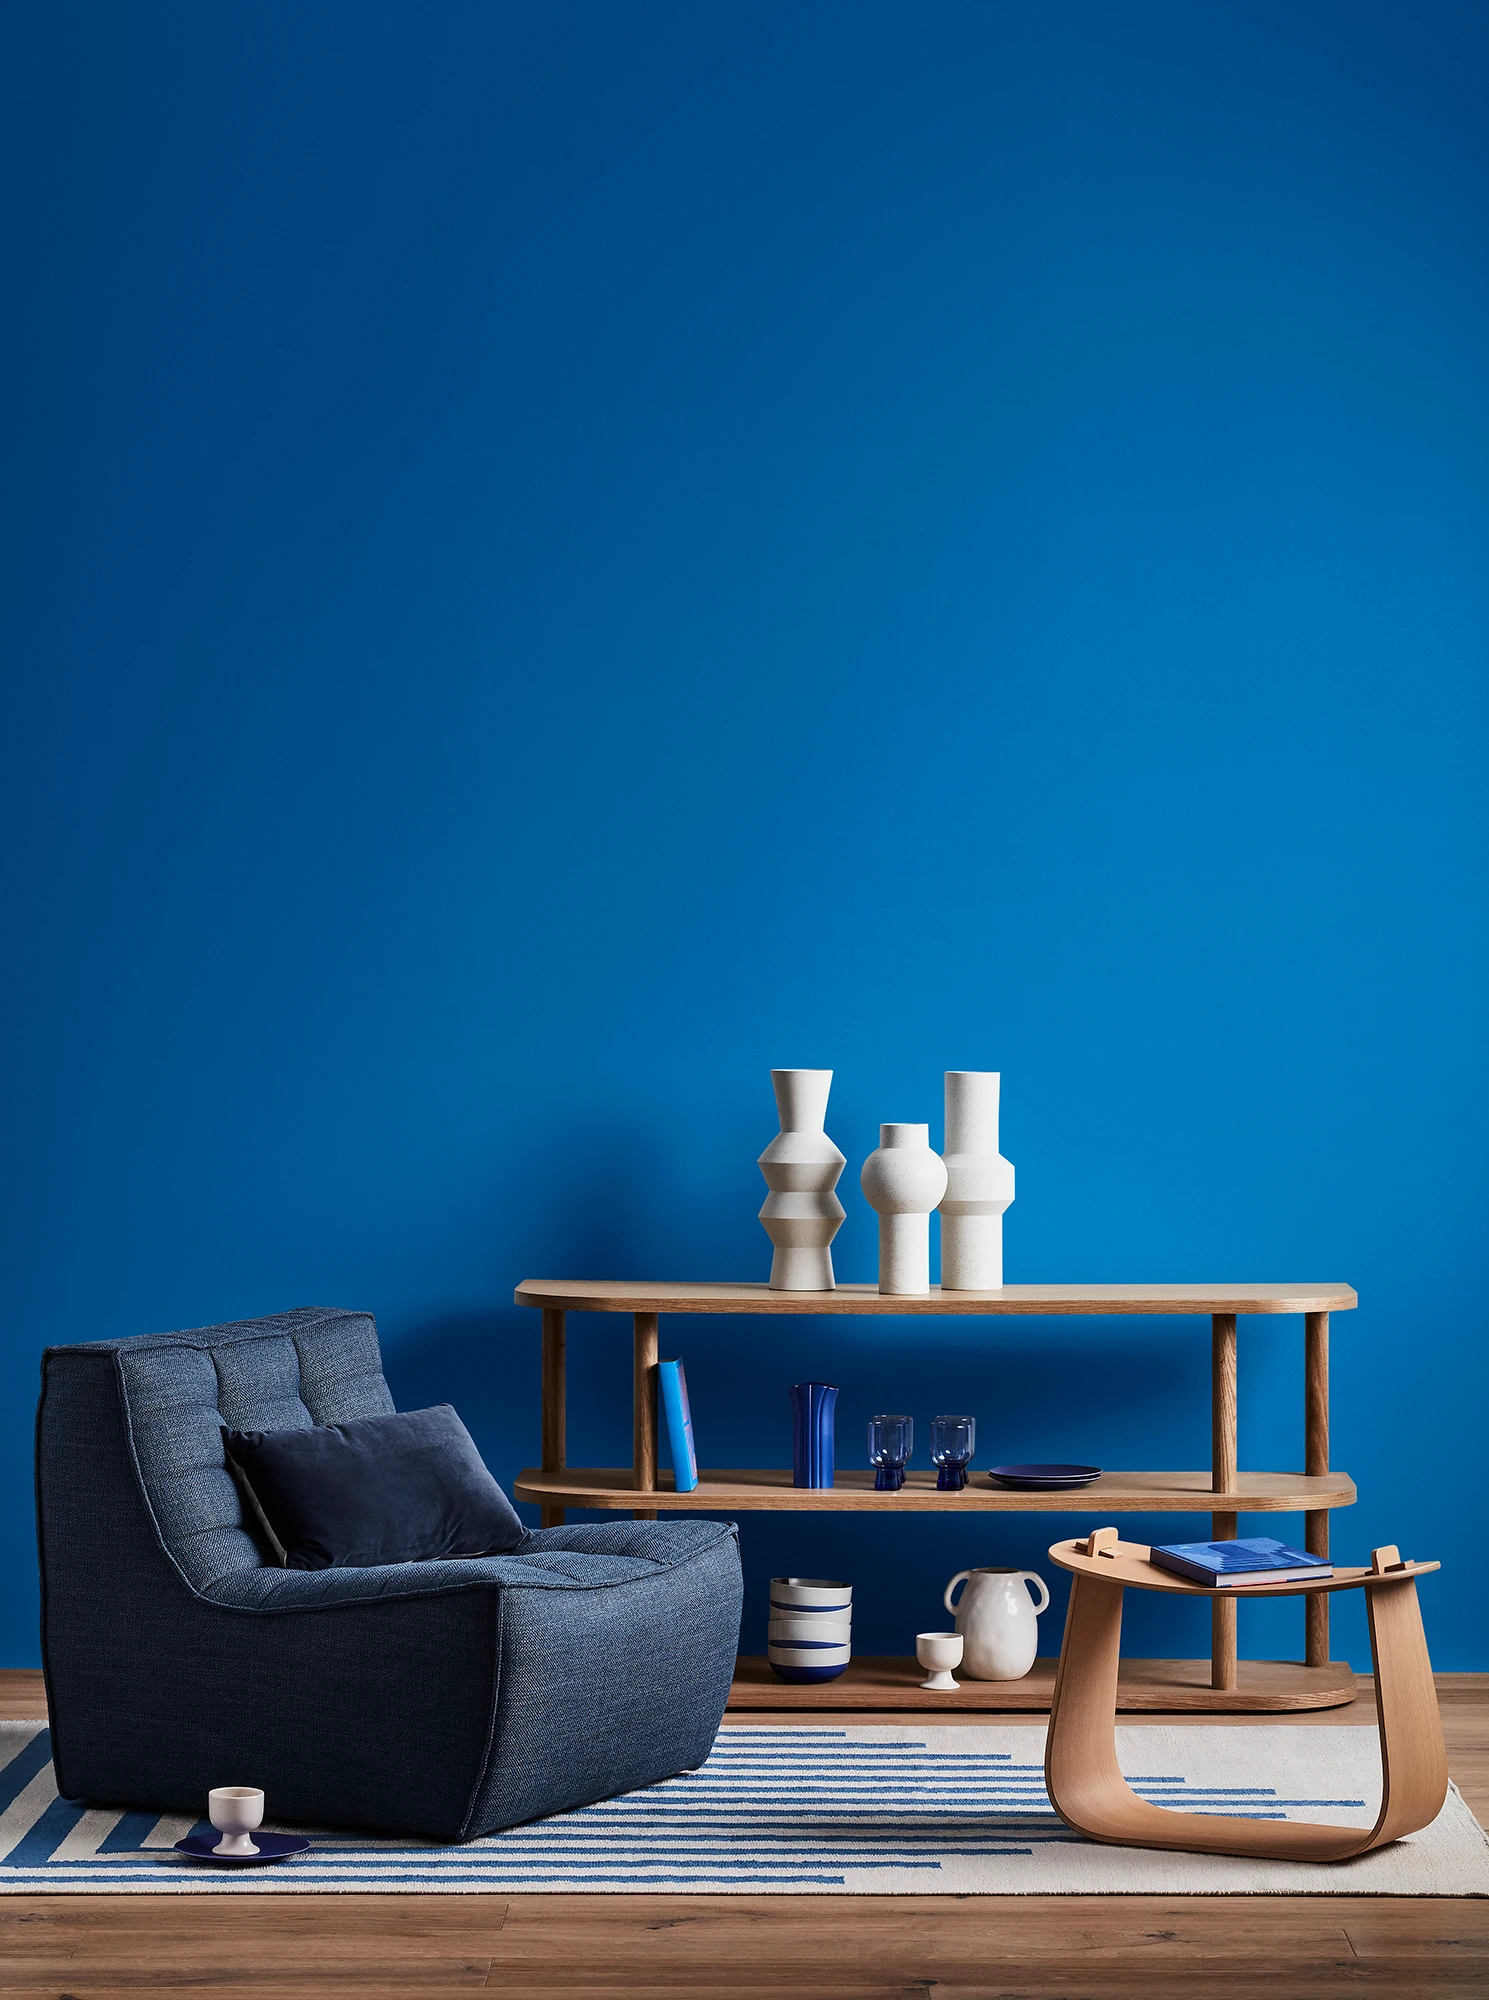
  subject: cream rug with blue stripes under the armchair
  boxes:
[0,1722,1489,1896]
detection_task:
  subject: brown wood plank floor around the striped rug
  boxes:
[0,1674,1489,2000]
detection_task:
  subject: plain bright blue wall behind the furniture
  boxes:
[0,0,1489,1668]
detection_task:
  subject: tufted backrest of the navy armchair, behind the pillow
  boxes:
[36,1306,392,1592]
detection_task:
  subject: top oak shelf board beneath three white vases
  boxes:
[516,1278,1357,1314]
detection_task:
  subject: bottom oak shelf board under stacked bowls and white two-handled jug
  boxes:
[728,1654,1355,1716]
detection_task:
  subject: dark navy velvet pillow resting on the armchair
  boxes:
[222,1402,526,1570]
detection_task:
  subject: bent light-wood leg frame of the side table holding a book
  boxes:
[1045,1528,1447,1862]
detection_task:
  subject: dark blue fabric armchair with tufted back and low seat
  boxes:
[36,1308,740,1840]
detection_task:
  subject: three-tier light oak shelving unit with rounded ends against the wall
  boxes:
[516,1278,1357,1714]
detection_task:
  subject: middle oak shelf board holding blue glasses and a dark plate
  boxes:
[516,1466,1355,1514]
